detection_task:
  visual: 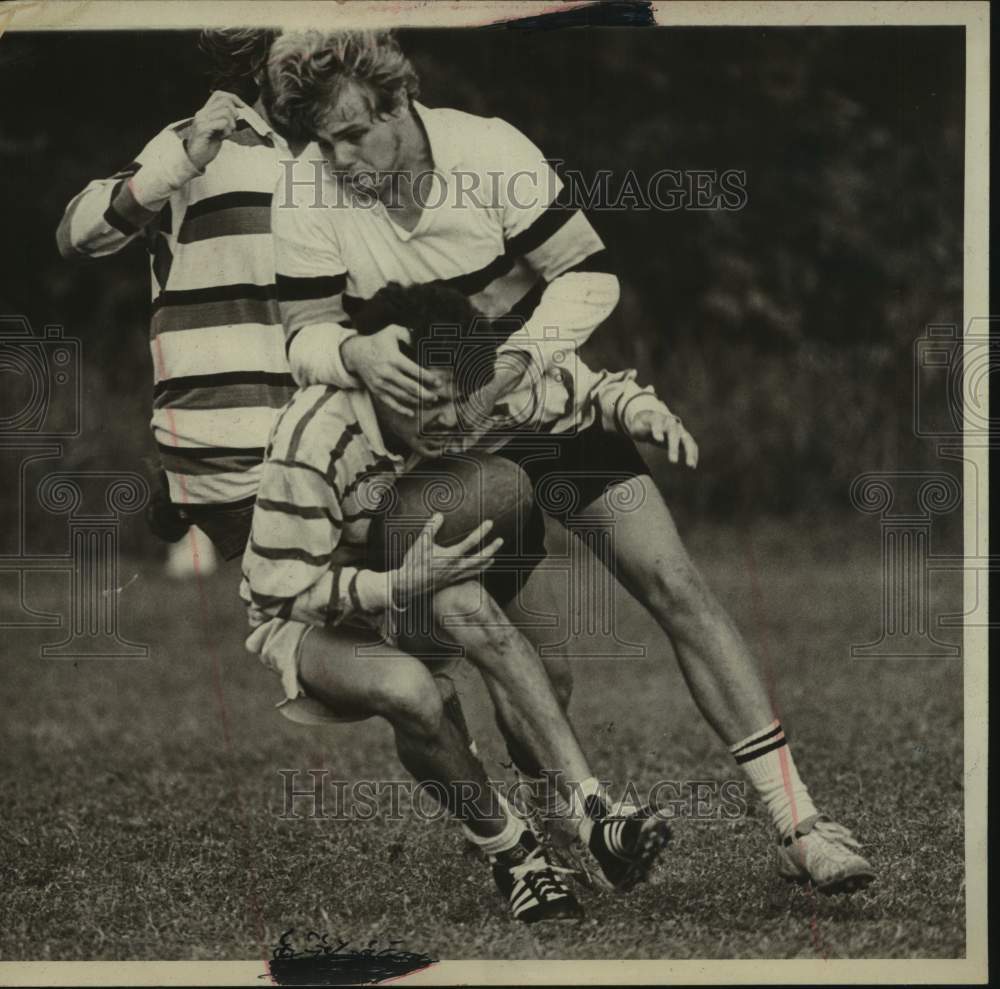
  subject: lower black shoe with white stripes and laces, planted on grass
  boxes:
[490,830,583,924]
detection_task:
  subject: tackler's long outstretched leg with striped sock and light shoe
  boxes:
[582,475,874,892]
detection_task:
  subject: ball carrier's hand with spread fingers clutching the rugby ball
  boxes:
[391,514,503,604]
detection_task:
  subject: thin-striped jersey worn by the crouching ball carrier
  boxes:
[240,364,666,628]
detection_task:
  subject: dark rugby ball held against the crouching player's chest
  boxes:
[368,453,545,605]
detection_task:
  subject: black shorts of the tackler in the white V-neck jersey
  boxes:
[496,423,649,521]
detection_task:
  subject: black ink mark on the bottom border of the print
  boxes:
[262,928,437,986]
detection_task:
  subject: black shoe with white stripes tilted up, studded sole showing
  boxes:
[579,796,670,892]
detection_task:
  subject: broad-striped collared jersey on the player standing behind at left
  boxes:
[57,109,295,505]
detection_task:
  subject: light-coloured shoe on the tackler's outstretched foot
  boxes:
[778,814,875,894]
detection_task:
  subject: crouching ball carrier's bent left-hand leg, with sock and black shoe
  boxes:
[298,628,581,923]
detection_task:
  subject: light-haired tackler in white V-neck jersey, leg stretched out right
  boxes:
[268,31,874,892]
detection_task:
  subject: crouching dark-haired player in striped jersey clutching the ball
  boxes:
[241,287,669,922]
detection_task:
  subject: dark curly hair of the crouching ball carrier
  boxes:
[352,281,506,394]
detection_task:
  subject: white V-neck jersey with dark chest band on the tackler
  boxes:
[272,102,618,388]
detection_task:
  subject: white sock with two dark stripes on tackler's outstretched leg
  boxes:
[729,719,817,838]
